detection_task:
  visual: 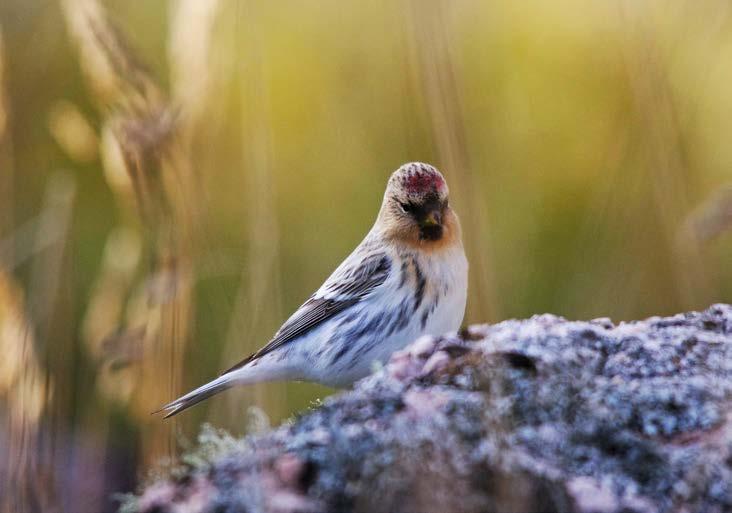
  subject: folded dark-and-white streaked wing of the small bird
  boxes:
[224,251,391,374]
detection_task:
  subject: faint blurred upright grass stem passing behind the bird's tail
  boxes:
[214,0,286,422]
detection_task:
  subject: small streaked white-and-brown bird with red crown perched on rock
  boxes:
[156,162,468,418]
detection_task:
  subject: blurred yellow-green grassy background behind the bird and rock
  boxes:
[0,0,732,513]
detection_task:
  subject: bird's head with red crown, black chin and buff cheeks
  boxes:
[378,162,460,247]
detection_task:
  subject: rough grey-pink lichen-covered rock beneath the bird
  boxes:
[128,305,732,513]
